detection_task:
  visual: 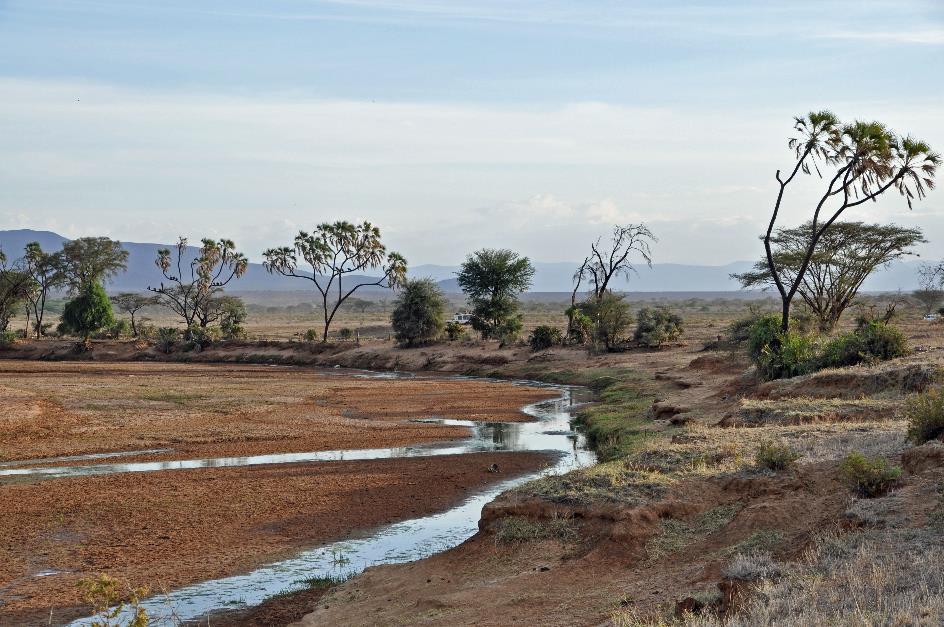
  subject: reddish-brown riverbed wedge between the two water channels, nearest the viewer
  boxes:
[0,453,551,625]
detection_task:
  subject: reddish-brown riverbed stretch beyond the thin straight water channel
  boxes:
[0,360,555,463]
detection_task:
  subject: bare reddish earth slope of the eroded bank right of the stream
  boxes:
[294,466,850,627]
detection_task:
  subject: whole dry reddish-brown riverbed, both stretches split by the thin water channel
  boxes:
[0,361,556,624]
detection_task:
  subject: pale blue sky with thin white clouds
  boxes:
[0,0,944,265]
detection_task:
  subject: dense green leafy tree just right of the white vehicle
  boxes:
[458,248,534,338]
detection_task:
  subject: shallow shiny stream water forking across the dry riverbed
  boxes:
[53,376,596,625]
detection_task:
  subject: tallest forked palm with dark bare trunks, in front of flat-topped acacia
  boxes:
[764,111,941,332]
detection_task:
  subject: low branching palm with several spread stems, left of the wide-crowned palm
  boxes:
[148,237,249,334]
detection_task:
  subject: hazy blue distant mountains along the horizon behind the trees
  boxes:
[0,229,921,293]
